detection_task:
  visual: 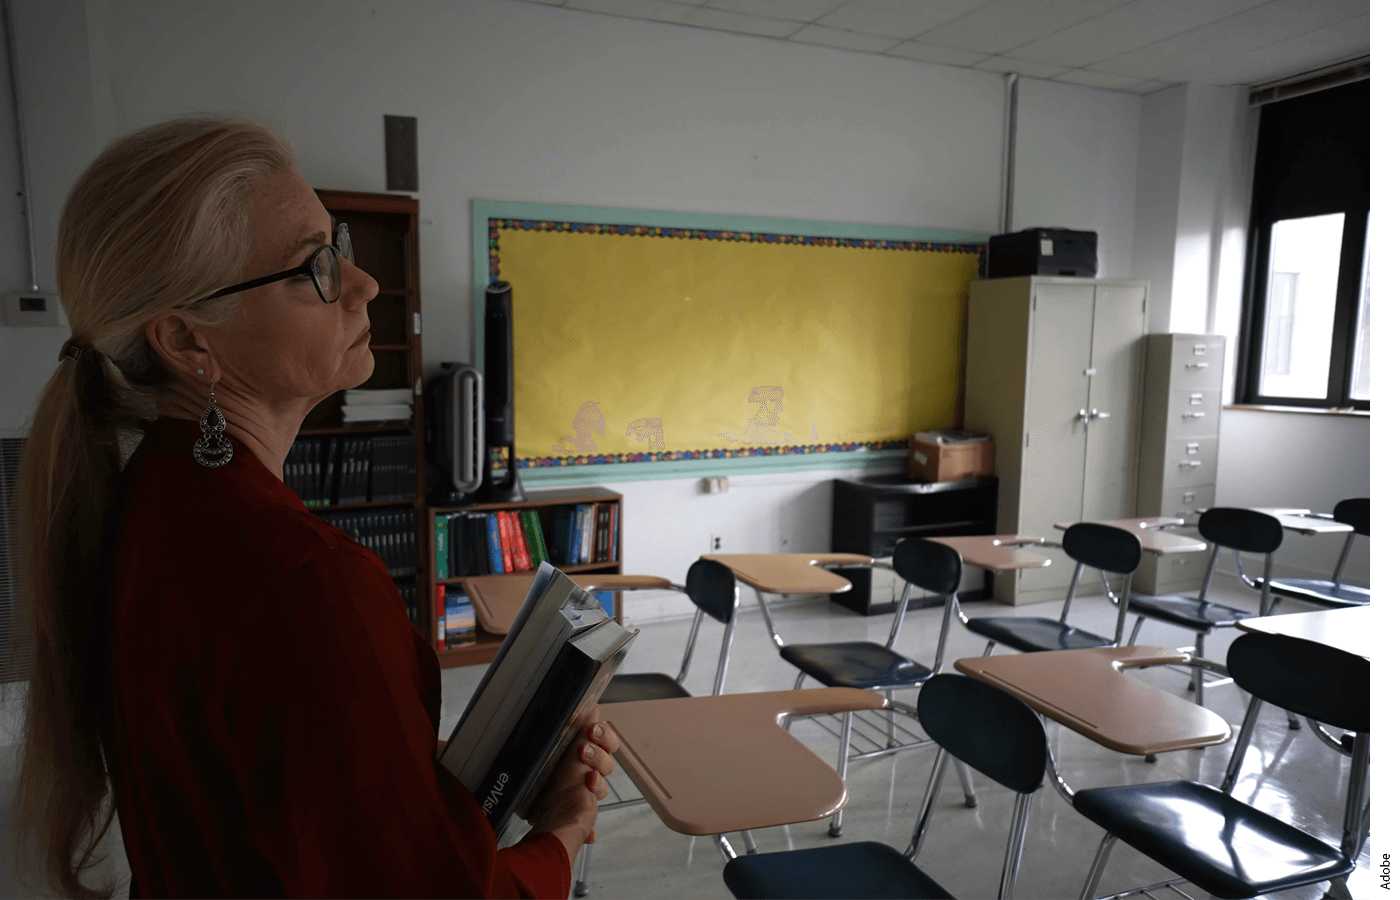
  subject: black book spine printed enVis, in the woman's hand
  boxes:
[475,644,601,834]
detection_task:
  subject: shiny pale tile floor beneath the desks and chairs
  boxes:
[0,578,1371,900]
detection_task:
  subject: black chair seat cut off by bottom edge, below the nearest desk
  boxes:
[724,841,953,900]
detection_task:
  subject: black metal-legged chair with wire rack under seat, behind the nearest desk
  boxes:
[755,540,977,837]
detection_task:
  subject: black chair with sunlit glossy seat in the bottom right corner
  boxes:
[1070,634,1371,900]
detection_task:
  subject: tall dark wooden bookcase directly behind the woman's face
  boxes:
[306,190,431,637]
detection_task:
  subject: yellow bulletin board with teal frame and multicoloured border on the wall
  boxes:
[473,202,986,479]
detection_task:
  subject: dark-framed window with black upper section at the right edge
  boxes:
[1238,81,1371,409]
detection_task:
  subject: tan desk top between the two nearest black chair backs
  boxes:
[953,647,1231,756]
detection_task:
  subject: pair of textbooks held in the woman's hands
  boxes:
[438,563,637,847]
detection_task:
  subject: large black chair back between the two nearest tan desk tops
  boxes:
[918,673,1047,794]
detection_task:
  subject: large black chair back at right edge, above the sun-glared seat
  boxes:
[1225,634,1371,733]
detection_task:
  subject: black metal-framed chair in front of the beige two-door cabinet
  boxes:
[934,522,1142,672]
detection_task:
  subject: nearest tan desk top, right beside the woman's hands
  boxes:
[599,687,885,834]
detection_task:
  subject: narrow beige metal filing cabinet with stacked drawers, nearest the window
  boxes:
[1133,335,1225,593]
